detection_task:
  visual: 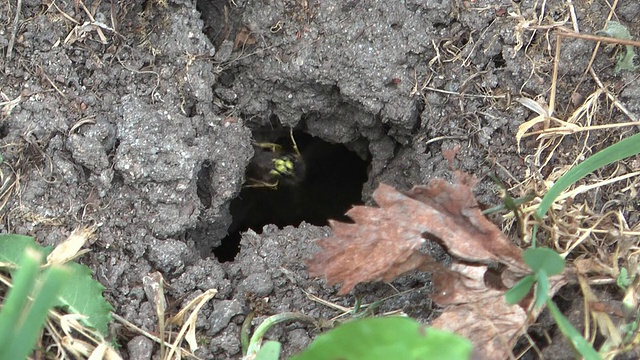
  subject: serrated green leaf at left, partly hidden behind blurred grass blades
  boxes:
[0,235,113,337]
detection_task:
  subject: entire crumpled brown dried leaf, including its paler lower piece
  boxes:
[307,176,566,359]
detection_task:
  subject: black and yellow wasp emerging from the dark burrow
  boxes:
[245,129,305,190]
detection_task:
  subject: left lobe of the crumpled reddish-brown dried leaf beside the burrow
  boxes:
[308,191,434,294]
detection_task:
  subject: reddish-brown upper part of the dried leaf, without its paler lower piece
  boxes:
[308,175,526,294]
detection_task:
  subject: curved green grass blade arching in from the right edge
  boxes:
[537,134,640,218]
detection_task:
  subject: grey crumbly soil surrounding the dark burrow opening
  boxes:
[0,0,640,359]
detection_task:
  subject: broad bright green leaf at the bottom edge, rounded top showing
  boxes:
[292,317,472,360]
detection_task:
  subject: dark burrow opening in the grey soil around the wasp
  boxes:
[213,128,369,262]
